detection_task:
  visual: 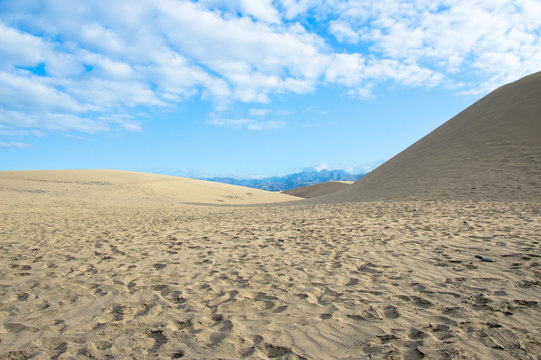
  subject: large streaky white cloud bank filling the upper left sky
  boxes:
[0,0,328,136]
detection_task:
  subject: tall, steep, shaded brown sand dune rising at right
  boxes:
[312,72,541,202]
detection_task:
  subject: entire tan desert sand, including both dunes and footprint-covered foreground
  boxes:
[0,74,541,360]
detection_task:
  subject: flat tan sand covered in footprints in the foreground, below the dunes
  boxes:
[0,201,541,359]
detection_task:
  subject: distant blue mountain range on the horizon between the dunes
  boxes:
[201,170,364,191]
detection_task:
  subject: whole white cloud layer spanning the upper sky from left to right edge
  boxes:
[0,0,541,138]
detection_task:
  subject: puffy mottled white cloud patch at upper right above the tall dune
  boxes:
[329,0,541,93]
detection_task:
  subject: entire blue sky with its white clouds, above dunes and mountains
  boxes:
[0,0,541,177]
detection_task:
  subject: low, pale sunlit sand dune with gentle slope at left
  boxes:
[0,170,298,206]
